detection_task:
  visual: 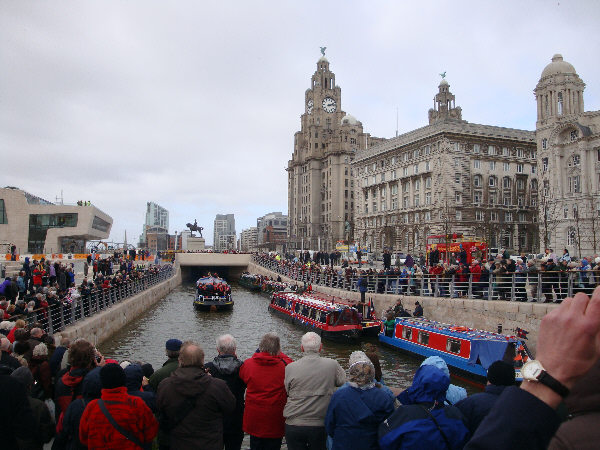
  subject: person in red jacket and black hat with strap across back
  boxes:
[79,364,158,450]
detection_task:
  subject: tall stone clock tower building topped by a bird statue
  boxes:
[286,56,383,250]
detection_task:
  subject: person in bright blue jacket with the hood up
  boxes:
[379,365,469,450]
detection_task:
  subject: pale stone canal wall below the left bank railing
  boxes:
[60,265,181,345]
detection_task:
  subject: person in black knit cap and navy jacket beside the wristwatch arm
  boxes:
[456,361,515,436]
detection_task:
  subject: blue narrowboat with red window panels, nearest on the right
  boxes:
[379,317,532,385]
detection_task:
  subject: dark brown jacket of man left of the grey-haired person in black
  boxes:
[156,367,235,450]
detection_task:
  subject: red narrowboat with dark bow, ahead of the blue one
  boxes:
[269,292,361,344]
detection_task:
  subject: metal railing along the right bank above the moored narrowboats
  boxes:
[252,255,600,302]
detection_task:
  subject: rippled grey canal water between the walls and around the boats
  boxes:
[99,284,477,393]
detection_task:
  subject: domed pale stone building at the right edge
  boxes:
[534,55,600,256]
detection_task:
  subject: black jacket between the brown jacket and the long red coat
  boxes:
[204,355,246,434]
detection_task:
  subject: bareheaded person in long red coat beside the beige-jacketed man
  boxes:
[240,333,292,450]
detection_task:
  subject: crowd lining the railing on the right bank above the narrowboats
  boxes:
[254,249,600,302]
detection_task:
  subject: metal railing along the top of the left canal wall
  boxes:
[10,264,176,334]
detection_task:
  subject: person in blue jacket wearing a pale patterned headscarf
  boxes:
[325,351,394,450]
